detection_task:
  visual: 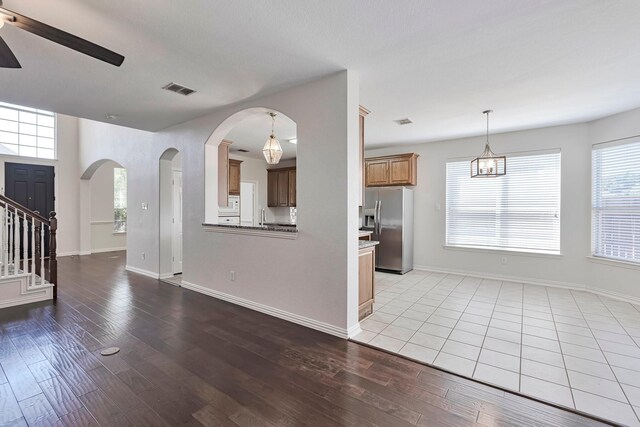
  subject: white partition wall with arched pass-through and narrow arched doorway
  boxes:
[80,71,359,342]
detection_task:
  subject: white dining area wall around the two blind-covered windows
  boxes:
[366,109,640,299]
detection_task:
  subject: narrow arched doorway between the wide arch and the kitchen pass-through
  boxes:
[159,148,183,286]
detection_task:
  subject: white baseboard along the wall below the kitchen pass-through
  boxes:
[182,280,350,339]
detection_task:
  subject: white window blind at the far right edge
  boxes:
[591,142,640,262]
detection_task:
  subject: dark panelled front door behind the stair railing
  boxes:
[4,163,55,256]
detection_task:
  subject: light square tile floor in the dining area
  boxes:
[354,271,640,426]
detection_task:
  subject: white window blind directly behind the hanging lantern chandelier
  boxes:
[446,152,560,253]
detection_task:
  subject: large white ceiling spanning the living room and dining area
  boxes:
[0,0,640,146]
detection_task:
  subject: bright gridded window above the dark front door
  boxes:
[0,102,56,159]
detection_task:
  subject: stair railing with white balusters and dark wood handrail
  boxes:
[0,194,58,300]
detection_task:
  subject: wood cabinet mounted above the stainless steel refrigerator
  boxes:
[365,153,418,187]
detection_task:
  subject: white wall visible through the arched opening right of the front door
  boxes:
[90,161,127,253]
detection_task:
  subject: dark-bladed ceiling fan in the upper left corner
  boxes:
[0,0,124,68]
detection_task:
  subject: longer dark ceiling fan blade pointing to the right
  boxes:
[0,7,124,67]
